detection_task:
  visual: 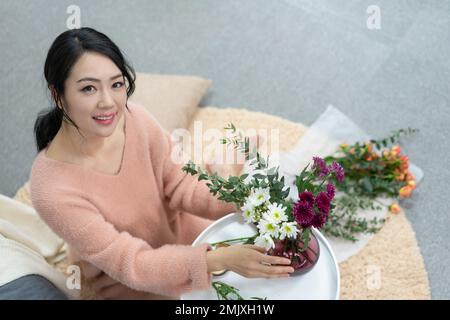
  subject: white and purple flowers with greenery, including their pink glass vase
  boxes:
[183,124,344,274]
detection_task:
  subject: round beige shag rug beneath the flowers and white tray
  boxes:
[15,107,431,299]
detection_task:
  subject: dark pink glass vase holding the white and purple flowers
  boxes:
[268,232,320,275]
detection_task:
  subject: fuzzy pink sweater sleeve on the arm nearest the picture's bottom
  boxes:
[33,190,211,297]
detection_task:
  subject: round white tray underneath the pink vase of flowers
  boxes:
[181,213,340,300]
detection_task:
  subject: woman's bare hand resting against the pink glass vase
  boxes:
[207,244,294,278]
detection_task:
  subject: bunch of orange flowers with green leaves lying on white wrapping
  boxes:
[322,128,418,242]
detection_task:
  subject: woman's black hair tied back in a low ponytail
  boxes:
[34,27,136,152]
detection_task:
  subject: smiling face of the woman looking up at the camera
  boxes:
[62,53,127,138]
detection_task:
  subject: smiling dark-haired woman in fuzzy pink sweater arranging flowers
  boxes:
[30,28,293,298]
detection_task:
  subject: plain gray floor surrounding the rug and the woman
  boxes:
[0,0,450,299]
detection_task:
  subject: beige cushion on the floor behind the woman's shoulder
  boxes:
[130,73,212,132]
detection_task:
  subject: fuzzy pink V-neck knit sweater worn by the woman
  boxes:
[30,102,235,298]
